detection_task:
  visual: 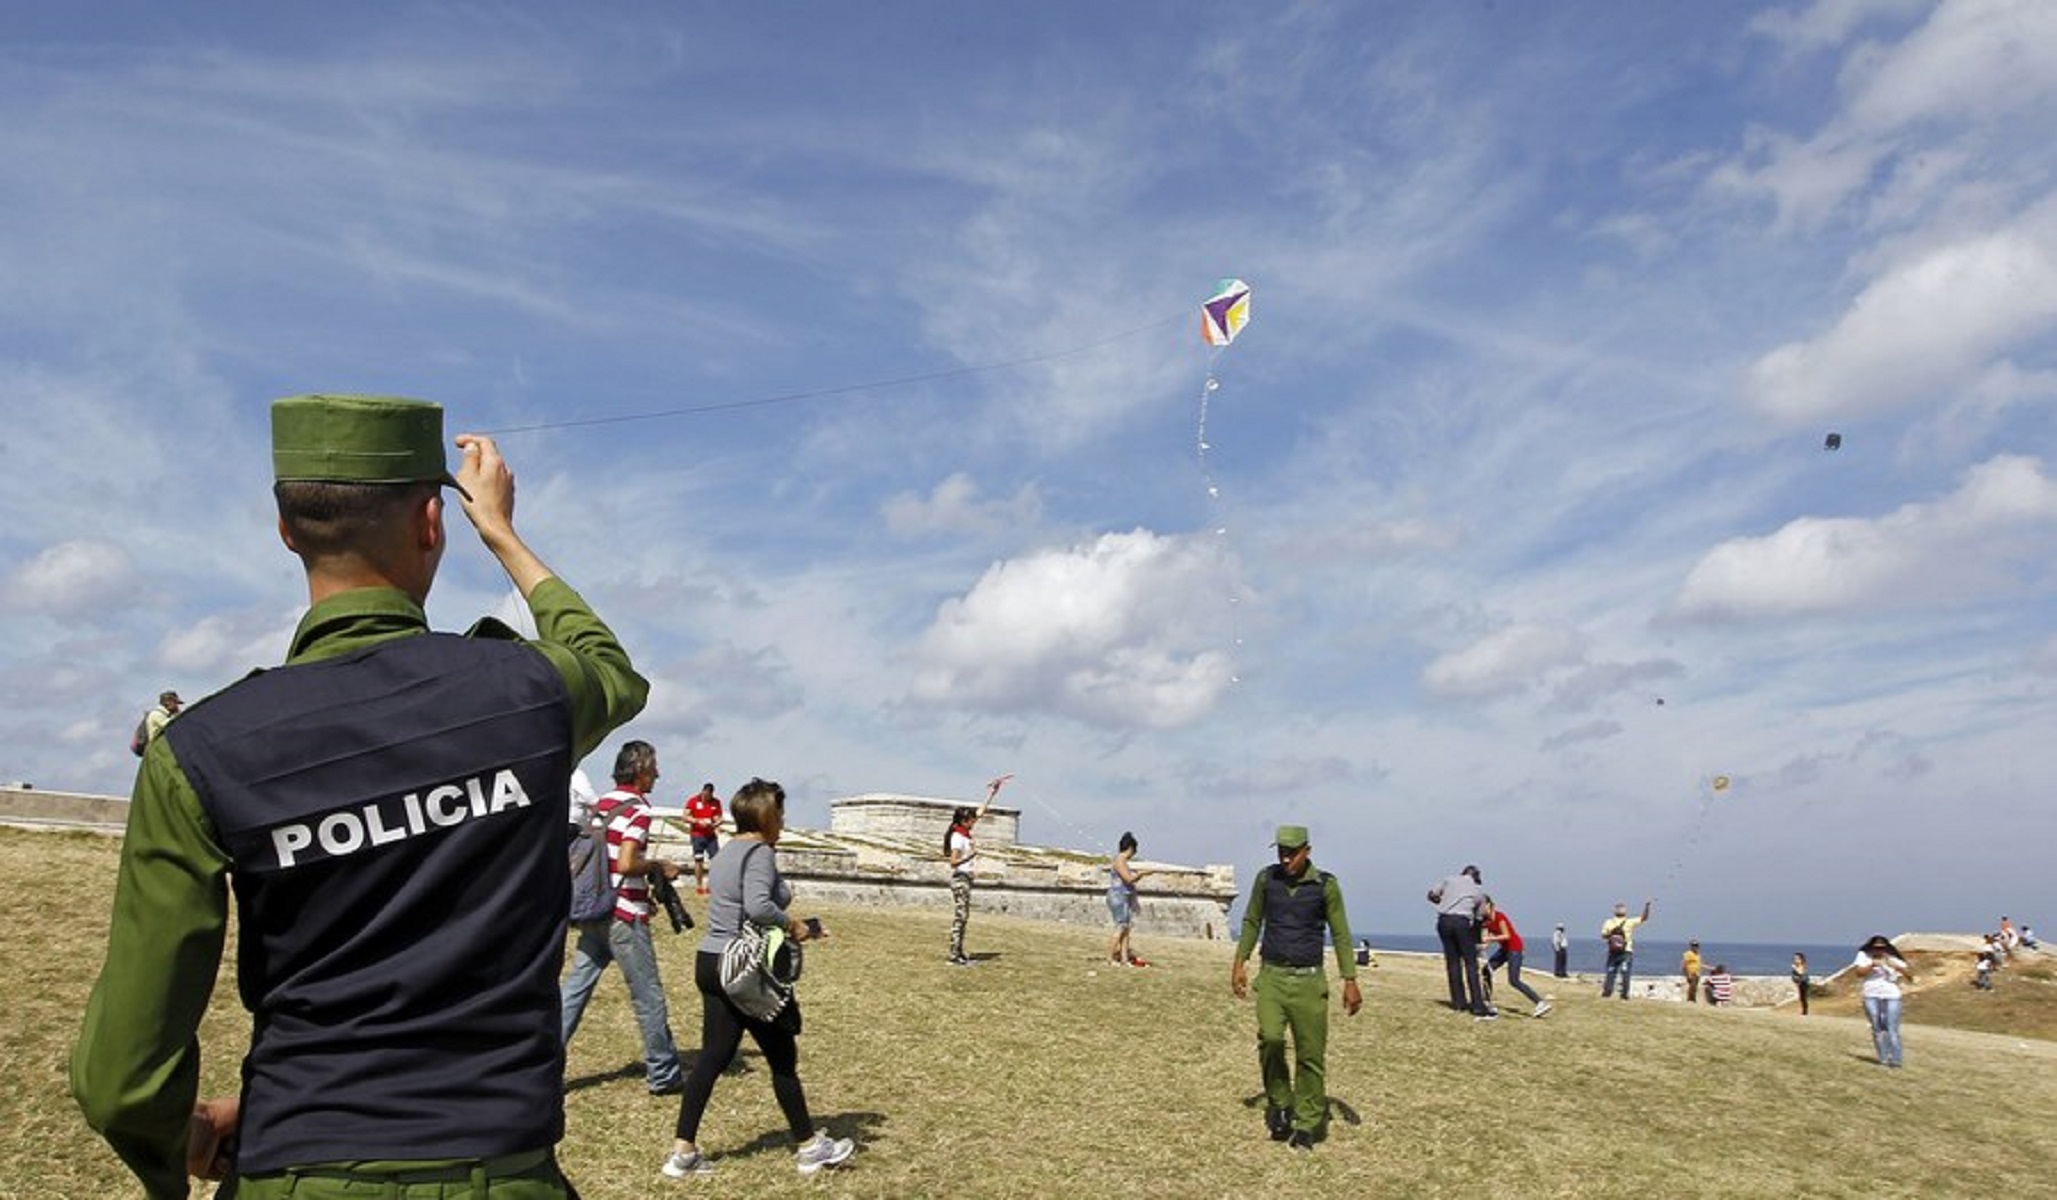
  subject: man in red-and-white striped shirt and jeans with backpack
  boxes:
[562,741,685,1095]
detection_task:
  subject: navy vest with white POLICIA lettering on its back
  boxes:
[165,634,572,1173]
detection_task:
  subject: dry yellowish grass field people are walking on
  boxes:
[0,830,2057,1200]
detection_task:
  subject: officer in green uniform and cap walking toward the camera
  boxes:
[1228,825,1364,1151]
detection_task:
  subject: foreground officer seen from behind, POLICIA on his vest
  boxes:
[72,395,648,1200]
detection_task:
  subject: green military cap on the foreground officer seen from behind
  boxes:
[272,395,469,498]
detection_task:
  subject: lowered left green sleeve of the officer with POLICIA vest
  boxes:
[72,739,228,1200]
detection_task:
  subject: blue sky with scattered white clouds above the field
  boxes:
[0,0,2057,941]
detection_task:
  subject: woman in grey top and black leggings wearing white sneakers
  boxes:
[664,780,858,1179]
